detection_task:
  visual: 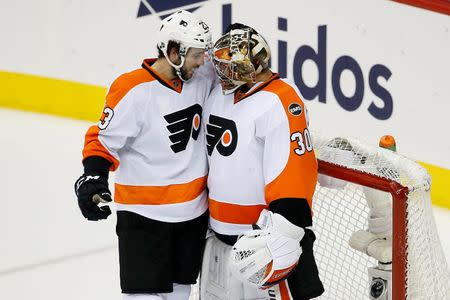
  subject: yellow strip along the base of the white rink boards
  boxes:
[0,71,450,209]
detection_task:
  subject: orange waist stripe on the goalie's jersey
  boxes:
[208,198,267,224]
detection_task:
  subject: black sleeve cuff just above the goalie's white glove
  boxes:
[269,198,312,228]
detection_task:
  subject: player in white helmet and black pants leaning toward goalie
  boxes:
[75,11,215,300]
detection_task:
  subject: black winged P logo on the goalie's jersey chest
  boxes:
[206,115,238,156]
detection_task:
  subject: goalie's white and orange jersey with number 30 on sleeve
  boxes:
[204,74,317,235]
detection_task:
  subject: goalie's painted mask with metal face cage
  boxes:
[211,25,270,95]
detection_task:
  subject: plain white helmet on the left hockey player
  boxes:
[157,10,212,81]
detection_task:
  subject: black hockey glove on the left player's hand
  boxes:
[75,157,112,221]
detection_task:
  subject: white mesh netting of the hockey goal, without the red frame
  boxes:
[313,136,450,299]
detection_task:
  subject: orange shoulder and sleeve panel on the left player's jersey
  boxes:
[83,69,155,171]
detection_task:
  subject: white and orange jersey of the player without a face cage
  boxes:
[83,59,215,222]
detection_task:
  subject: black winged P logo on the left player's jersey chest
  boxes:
[164,104,202,153]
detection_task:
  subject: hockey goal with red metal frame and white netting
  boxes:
[190,135,450,300]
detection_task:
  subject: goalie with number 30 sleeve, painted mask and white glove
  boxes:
[200,23,324,299]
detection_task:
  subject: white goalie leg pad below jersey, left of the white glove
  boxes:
[200,235,244,300]
